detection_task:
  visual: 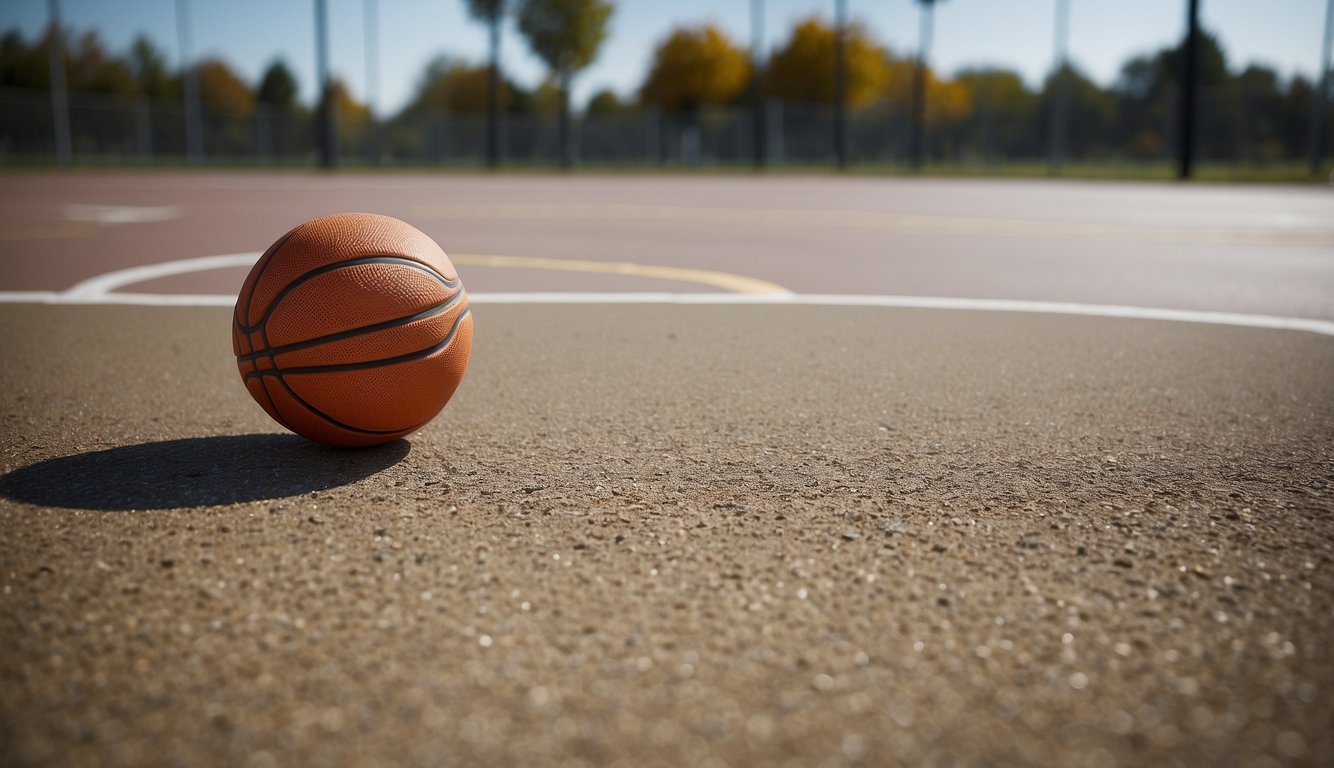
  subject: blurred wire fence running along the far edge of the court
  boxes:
[0,88,1334,167]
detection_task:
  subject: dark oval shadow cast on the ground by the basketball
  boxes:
[0,435,411,511]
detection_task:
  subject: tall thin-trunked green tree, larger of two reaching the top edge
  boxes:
[519,0,612,168]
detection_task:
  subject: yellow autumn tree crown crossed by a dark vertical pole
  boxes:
[764,16,890,107]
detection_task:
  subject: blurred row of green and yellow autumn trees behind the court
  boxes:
[0,0,1317,163]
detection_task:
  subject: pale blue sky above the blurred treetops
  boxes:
[0,0,1327,115]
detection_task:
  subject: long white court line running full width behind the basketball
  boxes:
[0,288,1334,336]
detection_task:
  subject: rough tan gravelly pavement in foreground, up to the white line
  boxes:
[0,305,1334,767]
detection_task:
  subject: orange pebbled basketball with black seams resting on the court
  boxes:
[232,213,472,448]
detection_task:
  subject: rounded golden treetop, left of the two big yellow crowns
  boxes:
[640,24,751,112]
